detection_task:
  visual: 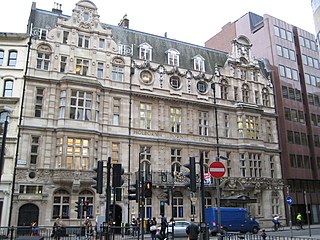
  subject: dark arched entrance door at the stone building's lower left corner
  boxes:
[18,203,39,235]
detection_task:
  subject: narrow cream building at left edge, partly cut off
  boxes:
[0,33,29,226]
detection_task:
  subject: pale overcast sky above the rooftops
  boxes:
[0,0,315,46]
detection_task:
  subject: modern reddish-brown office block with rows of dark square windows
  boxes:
[205,12,320,223]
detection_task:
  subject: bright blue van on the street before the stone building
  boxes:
[206,207,260,235]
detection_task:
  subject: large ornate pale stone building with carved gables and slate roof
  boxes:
[5,0,284,229]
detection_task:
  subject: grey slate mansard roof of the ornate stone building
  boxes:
[28,3,227,74]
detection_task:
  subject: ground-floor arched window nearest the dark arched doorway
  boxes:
[52,189,70,219]
